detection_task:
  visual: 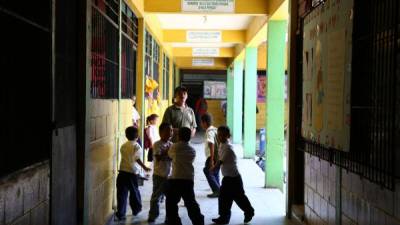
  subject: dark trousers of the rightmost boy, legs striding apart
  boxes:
[218,175,254,222]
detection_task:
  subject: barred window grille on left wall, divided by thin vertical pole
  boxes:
[91,0,138,99]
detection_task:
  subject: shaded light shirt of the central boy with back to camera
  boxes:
[168,141,196,180]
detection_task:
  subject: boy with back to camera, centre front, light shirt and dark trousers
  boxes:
[166,127,204,225]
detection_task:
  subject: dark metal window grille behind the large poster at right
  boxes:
[297,0,400,190]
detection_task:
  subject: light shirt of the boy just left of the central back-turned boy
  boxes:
[153,140,173,178]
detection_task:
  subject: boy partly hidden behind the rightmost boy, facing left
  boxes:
[200,113,220,198]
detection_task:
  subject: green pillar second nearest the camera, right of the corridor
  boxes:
[244,47,257,158]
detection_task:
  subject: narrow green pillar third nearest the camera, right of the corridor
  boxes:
[231,60,243,144]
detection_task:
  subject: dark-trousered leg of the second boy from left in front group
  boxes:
[149,175,167,220]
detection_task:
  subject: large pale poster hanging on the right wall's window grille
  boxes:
[301,0,354,151]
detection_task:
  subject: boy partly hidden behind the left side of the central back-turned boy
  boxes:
[147,123,173,223]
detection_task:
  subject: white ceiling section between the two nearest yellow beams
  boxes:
[157,14,253,30]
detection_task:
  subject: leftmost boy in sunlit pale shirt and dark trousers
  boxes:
[115,126,150,220]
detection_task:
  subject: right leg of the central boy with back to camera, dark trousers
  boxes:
[182,180,204,225]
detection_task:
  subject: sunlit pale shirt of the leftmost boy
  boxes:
[119,141,142,174]
